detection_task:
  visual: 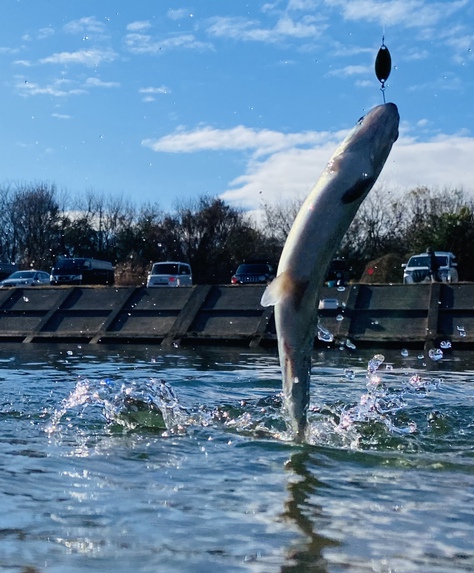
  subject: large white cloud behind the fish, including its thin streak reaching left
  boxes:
[142,125,474,210]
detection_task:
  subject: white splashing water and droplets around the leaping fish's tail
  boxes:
[45,351,442,449]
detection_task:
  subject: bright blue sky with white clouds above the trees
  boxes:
[0,0,474,217]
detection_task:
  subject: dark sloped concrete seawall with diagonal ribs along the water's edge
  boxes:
[0,283,474,349]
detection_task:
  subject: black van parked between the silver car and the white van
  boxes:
[50,257,114,285]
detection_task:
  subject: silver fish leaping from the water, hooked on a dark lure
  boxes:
[261,103,400,442]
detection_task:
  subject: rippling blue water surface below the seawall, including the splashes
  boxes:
[0,345,474,573]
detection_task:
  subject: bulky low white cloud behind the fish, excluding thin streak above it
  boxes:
[221,131,474,209]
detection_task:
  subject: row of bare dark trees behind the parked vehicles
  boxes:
[0,183,474,284]
